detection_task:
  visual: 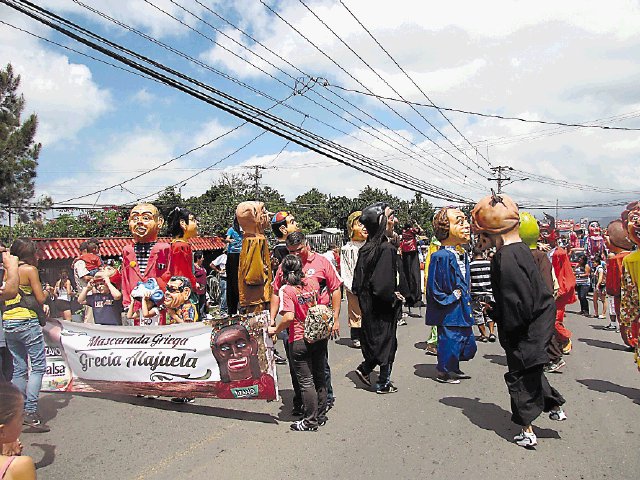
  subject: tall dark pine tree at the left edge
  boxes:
[0,64,42,219]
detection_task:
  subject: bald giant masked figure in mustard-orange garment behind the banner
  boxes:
[236,202,273,313]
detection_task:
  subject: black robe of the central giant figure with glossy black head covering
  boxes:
[352,241,402,365]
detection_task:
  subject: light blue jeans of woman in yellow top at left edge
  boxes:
[4,318,47,413]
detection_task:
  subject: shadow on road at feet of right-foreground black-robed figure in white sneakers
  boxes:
[440,397,560,442]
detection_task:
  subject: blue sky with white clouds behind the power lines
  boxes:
[0,0,640,219]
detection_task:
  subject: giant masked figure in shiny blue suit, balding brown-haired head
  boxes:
[426,207,477,383]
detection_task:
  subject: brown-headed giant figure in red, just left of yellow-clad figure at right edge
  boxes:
[604,218,633,338]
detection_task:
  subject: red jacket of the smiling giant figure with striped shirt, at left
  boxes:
[121,242,170,307]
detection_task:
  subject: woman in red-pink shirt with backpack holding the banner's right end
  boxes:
[268,255,328,432]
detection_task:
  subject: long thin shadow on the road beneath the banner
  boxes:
[69,393,278,424]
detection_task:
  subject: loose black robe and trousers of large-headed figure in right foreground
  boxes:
[491,242,565,426]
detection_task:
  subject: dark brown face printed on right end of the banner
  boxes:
[211,324,261,383]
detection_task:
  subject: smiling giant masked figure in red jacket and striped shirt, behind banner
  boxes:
[122,203,170,307]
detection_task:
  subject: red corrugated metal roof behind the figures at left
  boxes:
[32,237,225,260]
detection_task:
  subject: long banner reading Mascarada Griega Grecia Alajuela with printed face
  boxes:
[43,312,277,400]
